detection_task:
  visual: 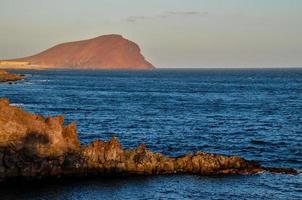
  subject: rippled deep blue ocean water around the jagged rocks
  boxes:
[0,69,302,199]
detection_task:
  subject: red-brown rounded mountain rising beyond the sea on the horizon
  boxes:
[16,35,154,69]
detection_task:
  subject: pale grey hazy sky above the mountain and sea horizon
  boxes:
[0,0,302,68]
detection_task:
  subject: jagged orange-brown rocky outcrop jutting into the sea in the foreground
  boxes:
[0,99,297,181]
